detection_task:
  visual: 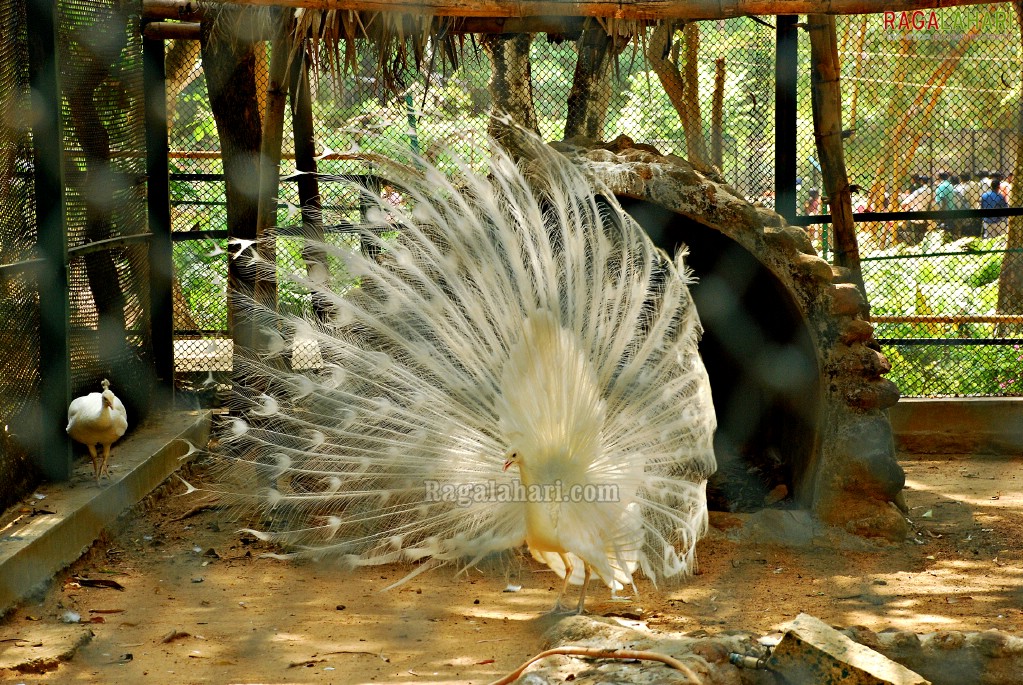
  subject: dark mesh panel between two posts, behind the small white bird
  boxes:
[58,0,153,423]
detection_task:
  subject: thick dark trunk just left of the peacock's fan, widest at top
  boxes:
[201,8,262,359]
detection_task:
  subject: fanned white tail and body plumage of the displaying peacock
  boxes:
[223,127,715,587]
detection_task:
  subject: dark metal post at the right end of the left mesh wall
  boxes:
[142,38,174,400]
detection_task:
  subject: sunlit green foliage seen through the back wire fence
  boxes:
[163,16,1023,395]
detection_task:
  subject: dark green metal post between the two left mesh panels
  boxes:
[26,0,72,481]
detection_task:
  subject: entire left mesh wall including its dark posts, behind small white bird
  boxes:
[0,0,153,507]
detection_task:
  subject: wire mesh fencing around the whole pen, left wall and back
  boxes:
[0,5,1023,503]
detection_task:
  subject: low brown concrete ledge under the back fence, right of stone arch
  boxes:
[888,398,1023,456]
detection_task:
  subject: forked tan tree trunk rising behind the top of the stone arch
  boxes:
[647,22,710,170]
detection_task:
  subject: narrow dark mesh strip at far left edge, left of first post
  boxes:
[0,0,40,510]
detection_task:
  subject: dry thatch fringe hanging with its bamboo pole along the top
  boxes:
[159,0,1006,95]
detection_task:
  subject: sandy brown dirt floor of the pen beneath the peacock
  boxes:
[0,455,1023,684]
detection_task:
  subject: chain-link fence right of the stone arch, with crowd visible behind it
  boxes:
[818,4,1023,396]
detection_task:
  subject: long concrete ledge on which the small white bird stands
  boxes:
[0,412,210,615]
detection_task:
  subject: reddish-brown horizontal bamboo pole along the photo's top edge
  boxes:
[199,0,1008,20]
